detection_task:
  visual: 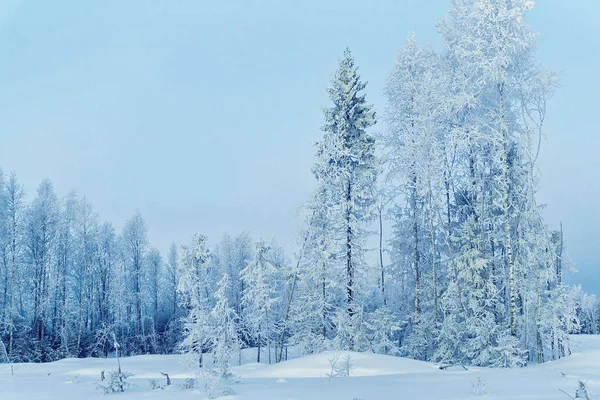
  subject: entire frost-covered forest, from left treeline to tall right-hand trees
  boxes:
[0,0,600,376]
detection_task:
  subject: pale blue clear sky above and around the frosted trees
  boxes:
[0,0,600,294]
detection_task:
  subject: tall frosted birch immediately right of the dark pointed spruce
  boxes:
[381,34,445,359]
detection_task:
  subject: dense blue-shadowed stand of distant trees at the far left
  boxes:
[0,171,285,362]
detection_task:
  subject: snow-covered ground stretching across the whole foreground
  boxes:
[0,335,600,400]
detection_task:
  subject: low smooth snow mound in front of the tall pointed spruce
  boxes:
[235,351,440,378]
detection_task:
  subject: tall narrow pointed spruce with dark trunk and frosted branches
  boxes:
[312,49,376,349]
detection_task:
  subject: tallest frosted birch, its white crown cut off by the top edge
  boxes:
[439,0,536,336]
